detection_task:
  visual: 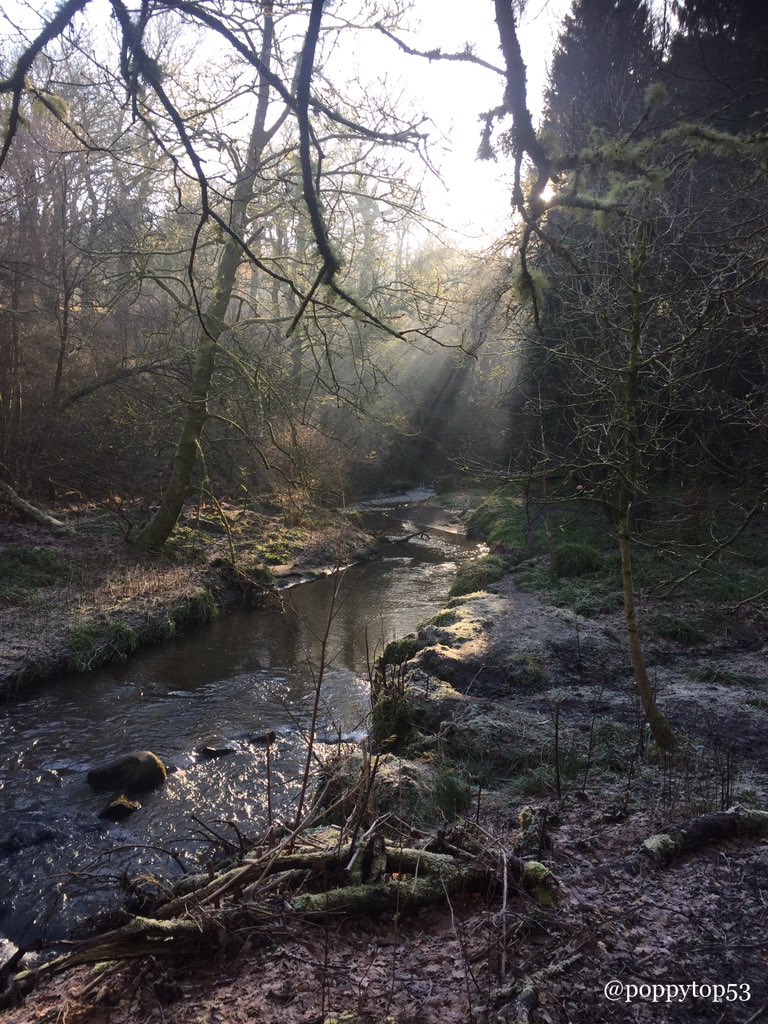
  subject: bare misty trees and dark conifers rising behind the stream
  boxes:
[0,0,766,561]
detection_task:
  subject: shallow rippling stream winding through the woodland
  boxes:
[0,492,476,946]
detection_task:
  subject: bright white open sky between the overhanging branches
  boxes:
[0,0,570,247]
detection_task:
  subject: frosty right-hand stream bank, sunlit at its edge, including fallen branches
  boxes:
[8,489,768,1024]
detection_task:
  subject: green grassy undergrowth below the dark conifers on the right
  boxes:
[468,483,768,614]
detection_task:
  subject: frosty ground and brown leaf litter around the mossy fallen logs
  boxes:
[5,493,768,1024]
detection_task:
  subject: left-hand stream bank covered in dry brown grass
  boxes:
[0,507,376,695]
